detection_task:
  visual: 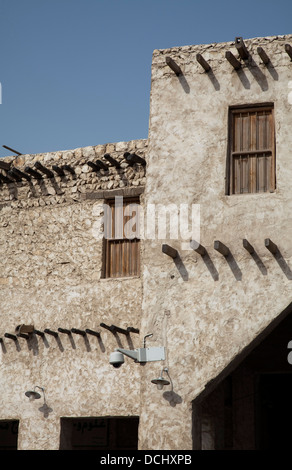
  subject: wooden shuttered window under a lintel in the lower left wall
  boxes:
[103,197,140,278]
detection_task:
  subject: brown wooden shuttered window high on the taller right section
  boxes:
[228,105,276,194]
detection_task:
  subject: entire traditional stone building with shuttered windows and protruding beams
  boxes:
[0,35,292,450]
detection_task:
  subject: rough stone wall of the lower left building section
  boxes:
[0,140,147,449]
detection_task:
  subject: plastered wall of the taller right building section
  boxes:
[140,36,292,449]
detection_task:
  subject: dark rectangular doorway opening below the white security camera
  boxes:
[60,416,139,450]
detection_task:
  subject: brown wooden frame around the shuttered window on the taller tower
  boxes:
[225,102,276,196]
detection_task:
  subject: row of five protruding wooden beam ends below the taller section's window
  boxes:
[162,238,279,259]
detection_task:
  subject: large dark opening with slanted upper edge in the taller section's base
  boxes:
[193,306,292,450]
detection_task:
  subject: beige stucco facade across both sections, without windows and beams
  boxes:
[0,36,292,450]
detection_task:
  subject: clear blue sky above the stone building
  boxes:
[0,0,292,157]
